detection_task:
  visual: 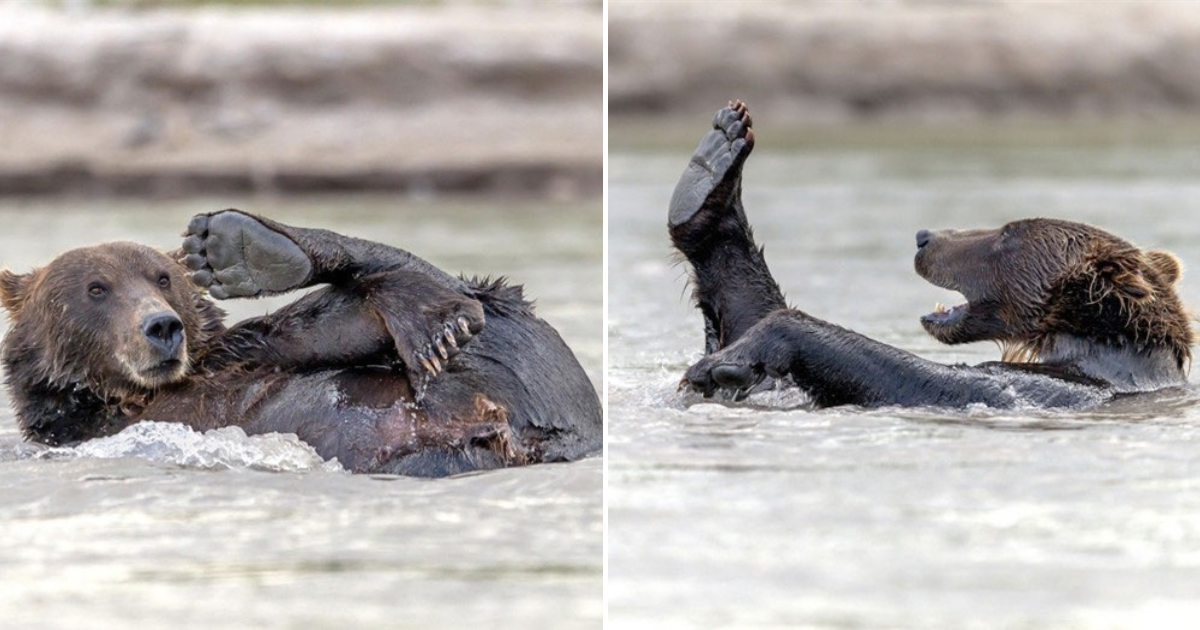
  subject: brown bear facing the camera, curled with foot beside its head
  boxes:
[0,210,601,476]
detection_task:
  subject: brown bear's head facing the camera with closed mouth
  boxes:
[0,242,223,442]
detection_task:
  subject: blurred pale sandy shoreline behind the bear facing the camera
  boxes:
[0,4,604,199]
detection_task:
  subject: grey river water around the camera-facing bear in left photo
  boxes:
[0,196,604,629]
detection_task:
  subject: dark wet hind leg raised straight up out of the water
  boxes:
[667,101,786,353]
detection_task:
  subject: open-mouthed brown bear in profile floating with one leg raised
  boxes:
[668,102,1195,407]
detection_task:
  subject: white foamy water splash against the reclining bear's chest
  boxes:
[36,422,343,472]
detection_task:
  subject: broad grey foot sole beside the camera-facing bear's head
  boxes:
[182,210,313,300]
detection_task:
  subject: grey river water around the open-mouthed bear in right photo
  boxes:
[607,125,1200,629]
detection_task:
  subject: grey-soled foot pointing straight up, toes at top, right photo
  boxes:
[667,101,754,229]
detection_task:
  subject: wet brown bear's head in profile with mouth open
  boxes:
[916,218,1194,378]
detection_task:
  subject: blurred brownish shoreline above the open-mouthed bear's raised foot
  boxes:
[610,0,1200,124]
